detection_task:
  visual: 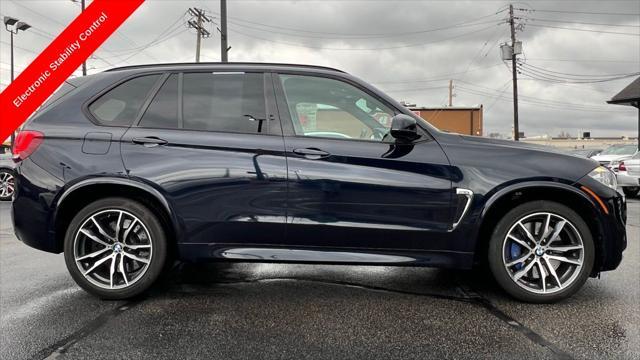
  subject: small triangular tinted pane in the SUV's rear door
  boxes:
[140,74,179,128]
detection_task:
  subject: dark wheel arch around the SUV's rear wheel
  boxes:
[50,177,181,253]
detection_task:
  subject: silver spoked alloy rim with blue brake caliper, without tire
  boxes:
[502,212,584,294]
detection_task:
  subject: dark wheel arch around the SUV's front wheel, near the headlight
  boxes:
[474,182,604,275]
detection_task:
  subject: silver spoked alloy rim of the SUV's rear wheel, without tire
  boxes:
[73,209,153,289]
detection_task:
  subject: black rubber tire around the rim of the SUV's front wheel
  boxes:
[488,201,595,303]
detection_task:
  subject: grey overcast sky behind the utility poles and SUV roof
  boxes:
[0,0,640,136]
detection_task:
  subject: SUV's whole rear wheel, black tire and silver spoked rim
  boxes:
[64,198,167,299]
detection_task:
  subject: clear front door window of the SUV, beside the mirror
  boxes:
[280,75,395,141]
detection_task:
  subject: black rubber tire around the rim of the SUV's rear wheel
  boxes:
[64,197,167,300]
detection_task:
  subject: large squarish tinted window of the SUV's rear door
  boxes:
[182,73,268,133]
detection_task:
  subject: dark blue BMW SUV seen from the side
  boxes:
[13,63,626,302]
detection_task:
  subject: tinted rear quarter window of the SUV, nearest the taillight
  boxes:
[89,75,160,126]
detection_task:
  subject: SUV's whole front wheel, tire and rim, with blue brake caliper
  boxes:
[489,201,594,303]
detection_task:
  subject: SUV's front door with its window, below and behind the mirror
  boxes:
[274,74,452,251]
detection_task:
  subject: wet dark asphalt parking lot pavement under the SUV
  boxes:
[0,200,640,359]
